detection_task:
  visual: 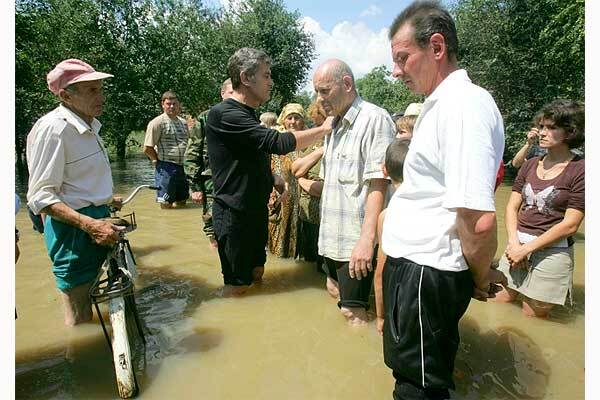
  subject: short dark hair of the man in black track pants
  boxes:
[389,0,458,59]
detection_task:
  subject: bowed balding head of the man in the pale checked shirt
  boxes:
[313,59,357,117]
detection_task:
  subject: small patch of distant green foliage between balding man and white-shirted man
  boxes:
[356,65,423,114]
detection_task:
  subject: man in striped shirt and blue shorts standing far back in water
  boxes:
[144,90,189,208]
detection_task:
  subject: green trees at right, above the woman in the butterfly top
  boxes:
[453,0,585,161]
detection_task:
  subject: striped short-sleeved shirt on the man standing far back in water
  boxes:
[144,113,188,165]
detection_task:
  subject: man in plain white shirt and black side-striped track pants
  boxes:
[382,1,505,399]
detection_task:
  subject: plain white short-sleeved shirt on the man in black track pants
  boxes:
[382,70,504,271]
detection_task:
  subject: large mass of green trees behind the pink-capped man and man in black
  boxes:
[15,0,314,162]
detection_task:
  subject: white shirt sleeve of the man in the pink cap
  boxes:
[27,124,65,214]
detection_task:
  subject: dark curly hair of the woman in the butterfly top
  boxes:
[533,99,585,149]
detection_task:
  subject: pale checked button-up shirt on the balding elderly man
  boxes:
[319,97,396,261]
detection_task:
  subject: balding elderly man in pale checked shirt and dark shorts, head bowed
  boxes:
[313,59,396,325]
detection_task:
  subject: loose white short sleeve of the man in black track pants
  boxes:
[440,98,504,211]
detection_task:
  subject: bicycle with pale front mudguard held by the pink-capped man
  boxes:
[90,185,158,399]
